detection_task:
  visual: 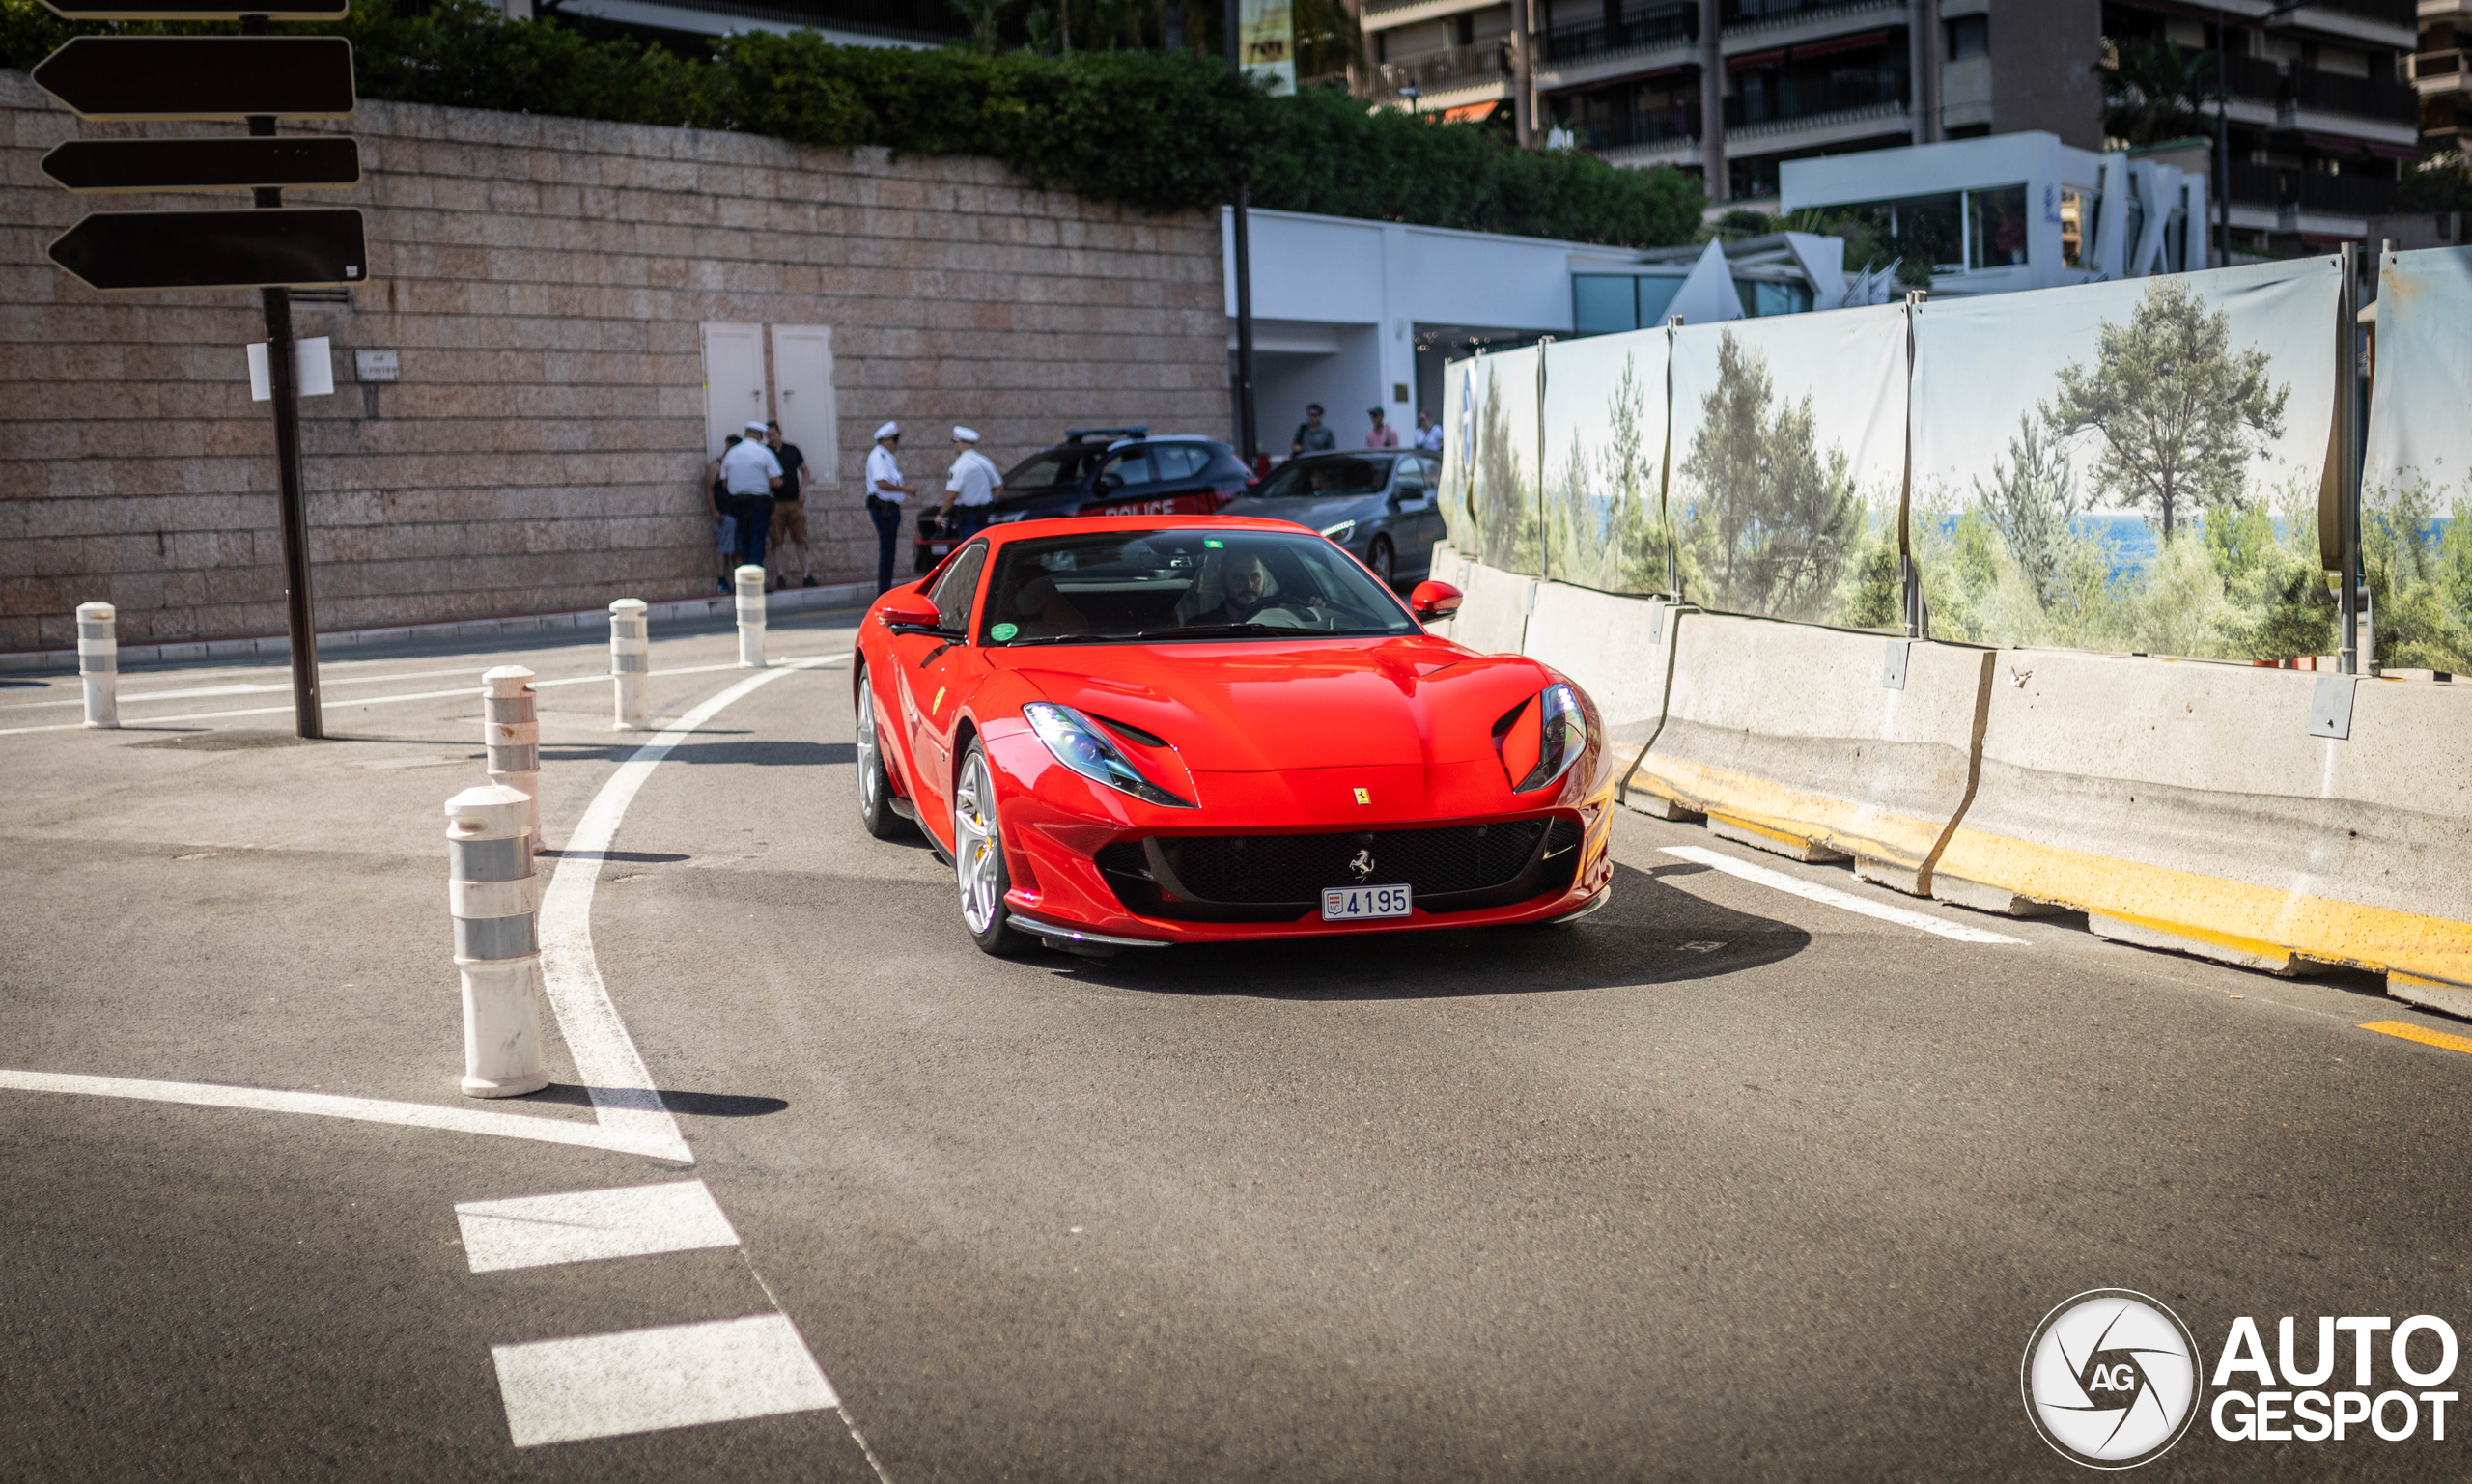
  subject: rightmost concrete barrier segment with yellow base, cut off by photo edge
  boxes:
[1933,651,2472,989]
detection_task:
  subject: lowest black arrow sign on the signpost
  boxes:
[52,210,368,290]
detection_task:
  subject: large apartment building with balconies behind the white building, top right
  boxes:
[1362,0,2412,252]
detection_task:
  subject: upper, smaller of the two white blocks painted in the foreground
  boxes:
[455,1180,739,1274]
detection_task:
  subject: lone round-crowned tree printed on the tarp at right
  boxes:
[2042,277,2291,545]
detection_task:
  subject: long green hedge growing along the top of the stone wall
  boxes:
[0,0,1703,247]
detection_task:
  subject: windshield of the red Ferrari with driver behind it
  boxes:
[979,529,1419,646]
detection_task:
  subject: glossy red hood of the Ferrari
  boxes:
[994,635,1553,771]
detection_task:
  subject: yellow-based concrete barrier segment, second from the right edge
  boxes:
[1624,611,1992,895]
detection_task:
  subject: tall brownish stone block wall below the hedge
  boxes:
[0,71,1228,651]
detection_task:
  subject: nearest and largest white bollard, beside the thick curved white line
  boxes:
[447,784,548,1098]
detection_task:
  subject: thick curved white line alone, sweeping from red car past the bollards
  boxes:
[539,653,851,1165]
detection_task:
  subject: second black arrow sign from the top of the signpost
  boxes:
[35,37,353,119]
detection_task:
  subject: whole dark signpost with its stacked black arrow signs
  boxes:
[32,0,368,737]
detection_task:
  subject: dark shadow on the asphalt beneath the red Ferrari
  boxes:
[1033,863,1812,999]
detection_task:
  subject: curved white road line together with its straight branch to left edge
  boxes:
[0,651,851,1165]
